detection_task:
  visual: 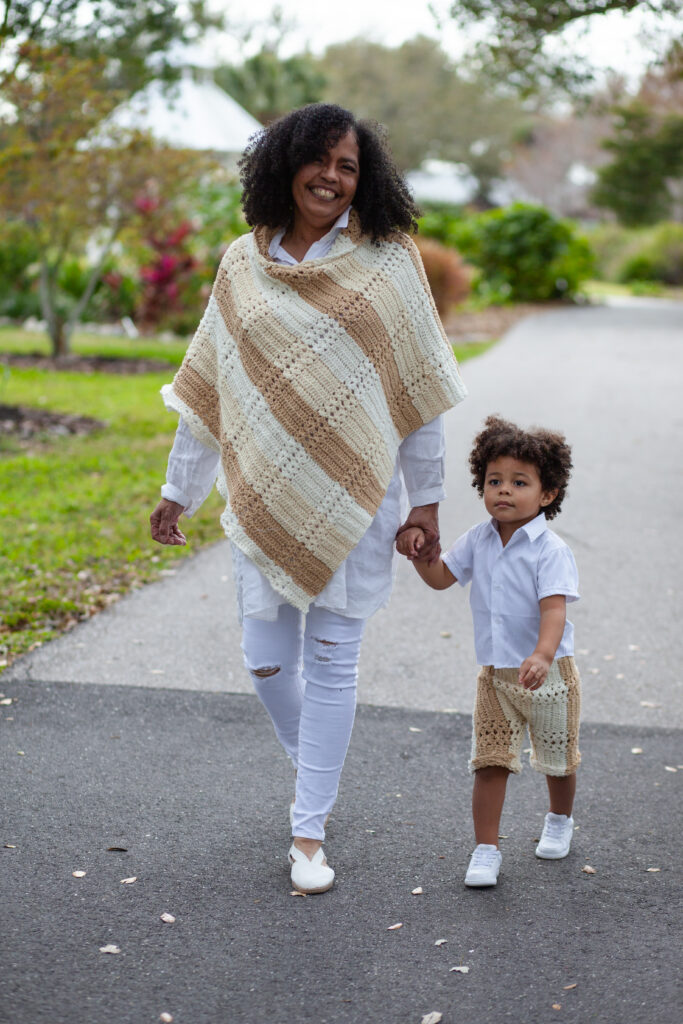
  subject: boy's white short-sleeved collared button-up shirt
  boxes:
[442,512,580,669]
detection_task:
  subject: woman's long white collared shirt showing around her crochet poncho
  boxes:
[161,207,445,621]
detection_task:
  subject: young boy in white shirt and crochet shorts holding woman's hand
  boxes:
[396,416,581,887]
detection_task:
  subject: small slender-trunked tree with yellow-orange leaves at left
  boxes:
[0,43,216,356]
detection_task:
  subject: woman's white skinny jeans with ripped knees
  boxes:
[242,604,366,840]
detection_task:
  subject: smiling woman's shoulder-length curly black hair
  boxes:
[240,103,420,242]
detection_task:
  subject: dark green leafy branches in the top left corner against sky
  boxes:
[0,0,223,93]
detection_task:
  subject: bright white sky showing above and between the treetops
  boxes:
[205,0,680,76]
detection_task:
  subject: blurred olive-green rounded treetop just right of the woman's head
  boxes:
[322,36,527,196]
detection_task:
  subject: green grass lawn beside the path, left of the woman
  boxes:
[0,329,492,672]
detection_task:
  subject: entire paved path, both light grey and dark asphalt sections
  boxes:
[0,304,683,1024]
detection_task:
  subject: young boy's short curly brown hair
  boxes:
[470,416,571,519]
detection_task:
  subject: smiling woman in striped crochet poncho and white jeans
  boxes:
[151,103,466,893]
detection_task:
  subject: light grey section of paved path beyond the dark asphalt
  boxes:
[4,303,683,727]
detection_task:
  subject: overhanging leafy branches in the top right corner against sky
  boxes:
[451,0,683,93]
